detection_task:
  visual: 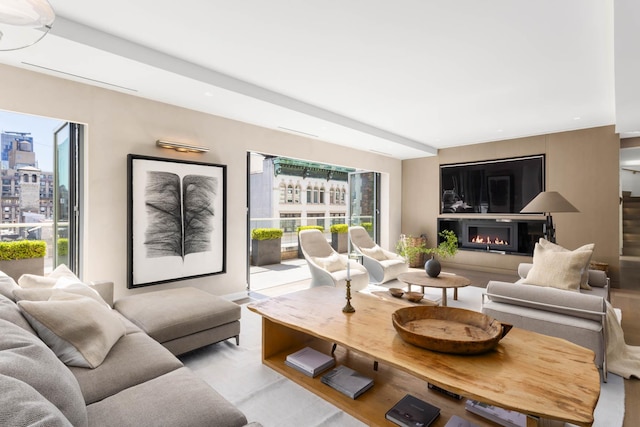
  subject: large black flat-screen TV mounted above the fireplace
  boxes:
[440,154,545,214]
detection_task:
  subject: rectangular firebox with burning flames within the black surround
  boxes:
[459,220,518,252]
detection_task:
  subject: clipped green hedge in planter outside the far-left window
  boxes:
[0,240,47,280]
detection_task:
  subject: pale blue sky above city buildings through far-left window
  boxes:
[0,110,66,172]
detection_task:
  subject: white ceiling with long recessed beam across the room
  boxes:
[0,0,640,159]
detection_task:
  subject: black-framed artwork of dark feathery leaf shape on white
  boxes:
[127,154,227,288]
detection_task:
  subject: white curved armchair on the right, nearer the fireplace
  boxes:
[349,226,409,284]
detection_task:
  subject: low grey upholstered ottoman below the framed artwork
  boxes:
[113,287,240,355]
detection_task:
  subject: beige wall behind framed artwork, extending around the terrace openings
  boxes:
[0,65,402,298]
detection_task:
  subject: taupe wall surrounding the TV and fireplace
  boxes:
[402,126,620,286]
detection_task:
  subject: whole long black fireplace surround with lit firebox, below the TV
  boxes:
[438,218,545,256]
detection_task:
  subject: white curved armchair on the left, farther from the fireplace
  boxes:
[298,229,369,291]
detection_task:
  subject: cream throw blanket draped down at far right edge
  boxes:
[605,302,640,379]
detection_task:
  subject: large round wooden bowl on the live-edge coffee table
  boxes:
[391,306,512,354]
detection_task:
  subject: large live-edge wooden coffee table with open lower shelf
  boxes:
[248,286,600,427]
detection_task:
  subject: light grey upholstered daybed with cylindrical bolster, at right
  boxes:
[482,263,609,382]
